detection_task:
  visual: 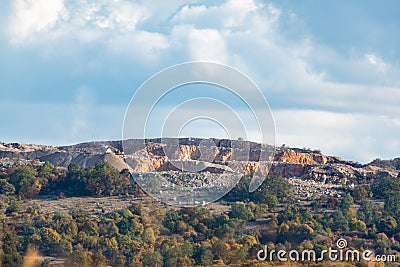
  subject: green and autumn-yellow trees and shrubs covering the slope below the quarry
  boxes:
[0,163,400,267]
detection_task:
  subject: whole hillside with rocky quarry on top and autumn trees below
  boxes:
[0,139,400,267]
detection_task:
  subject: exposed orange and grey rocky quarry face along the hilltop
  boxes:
[0,138,398,184]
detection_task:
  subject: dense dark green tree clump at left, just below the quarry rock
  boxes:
[0,162,130,199]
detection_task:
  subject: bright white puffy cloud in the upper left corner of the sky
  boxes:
[8,0,149,43]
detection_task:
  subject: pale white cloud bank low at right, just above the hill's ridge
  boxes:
[274,109,400,162]
